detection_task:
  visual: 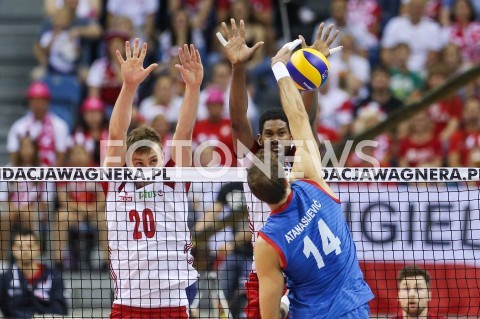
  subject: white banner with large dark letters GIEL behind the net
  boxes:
[333,184,480,266]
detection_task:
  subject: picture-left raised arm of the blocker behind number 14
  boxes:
[217,19,263,157]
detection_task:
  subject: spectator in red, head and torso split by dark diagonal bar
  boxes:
[426,64,463,145]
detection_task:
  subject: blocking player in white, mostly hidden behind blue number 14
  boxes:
[219,19,338,319]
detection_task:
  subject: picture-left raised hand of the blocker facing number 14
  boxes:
[217,19,264,64]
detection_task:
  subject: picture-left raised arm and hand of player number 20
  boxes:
[103,38,157,167]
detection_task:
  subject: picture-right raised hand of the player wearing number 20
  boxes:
[175,44,203,87]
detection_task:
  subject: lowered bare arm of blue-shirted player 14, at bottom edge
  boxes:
[253,237,285,319]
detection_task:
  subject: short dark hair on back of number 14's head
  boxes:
[247,149,287,204]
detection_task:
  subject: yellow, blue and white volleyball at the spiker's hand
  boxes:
[287,48,330,91]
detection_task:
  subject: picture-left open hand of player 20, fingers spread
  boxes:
[116,38,158,86]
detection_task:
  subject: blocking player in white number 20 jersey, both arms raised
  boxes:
[104,39,203,319]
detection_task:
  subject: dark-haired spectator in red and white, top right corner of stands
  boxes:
[448,0,480,64]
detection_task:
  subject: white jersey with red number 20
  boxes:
[106,182,198,308]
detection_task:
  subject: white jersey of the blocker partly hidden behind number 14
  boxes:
[237,147,295,272]
